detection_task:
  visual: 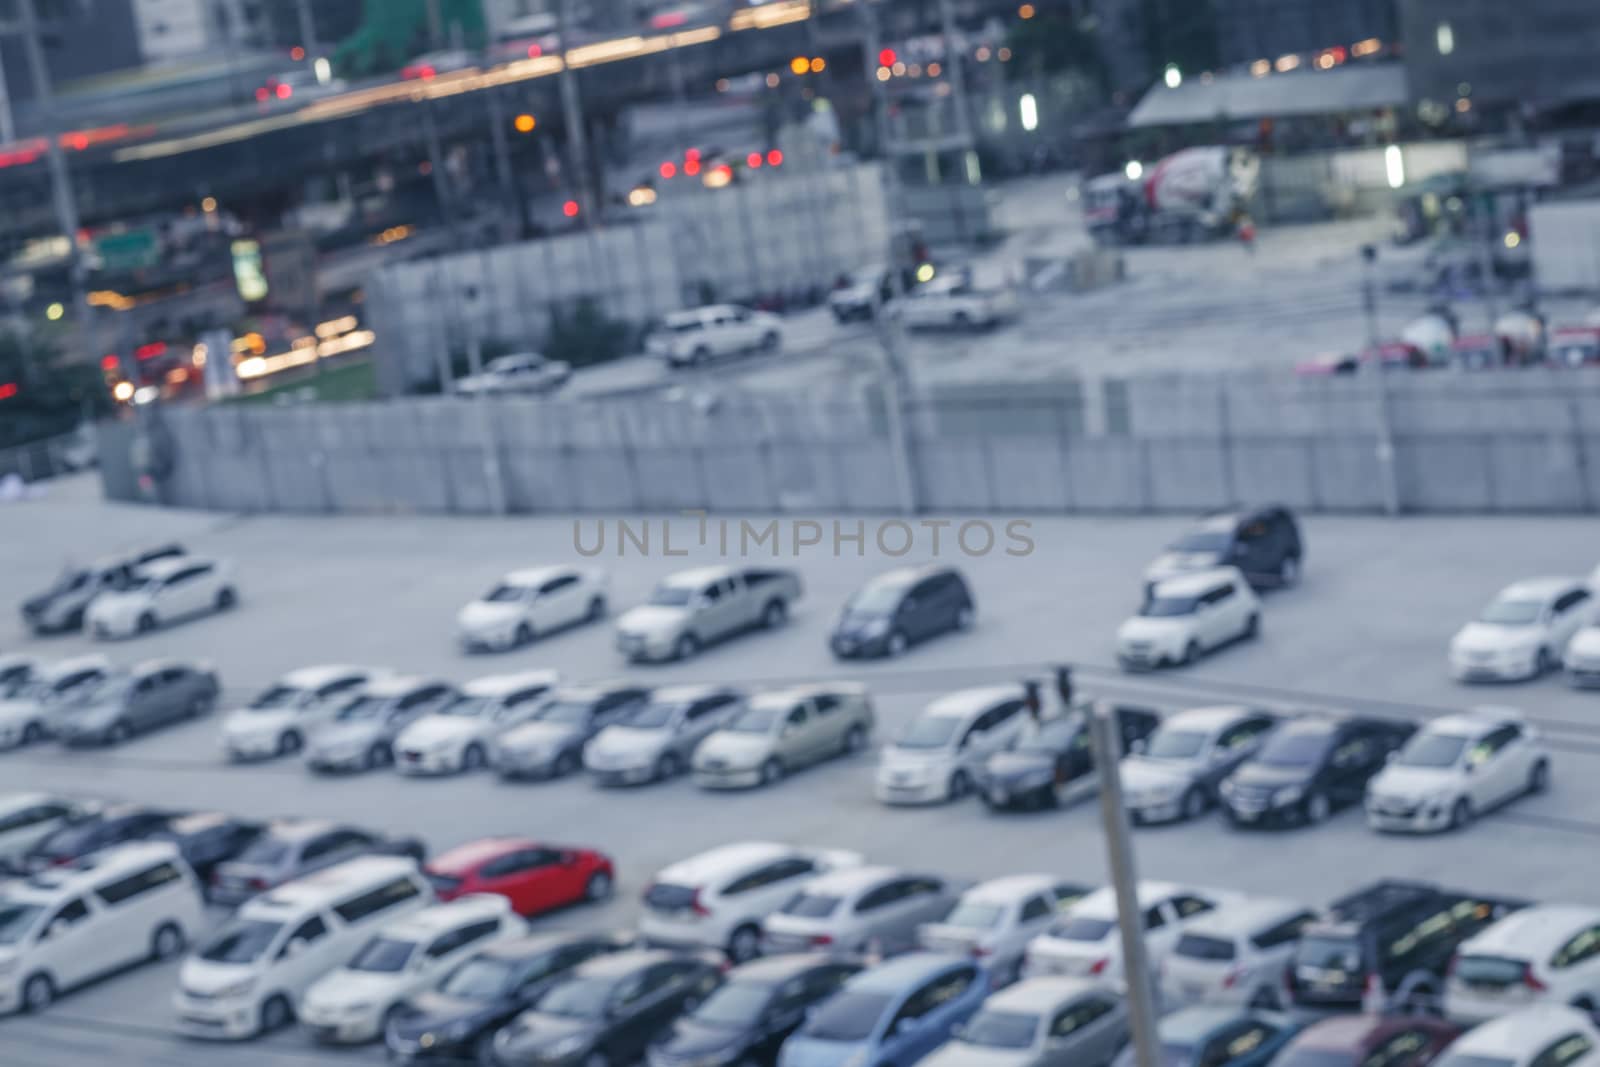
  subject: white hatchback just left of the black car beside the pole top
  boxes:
[874,685,1027,805]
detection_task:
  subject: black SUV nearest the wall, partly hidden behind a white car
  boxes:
[1144,507,1306,592]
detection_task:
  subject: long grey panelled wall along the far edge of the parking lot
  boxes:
[106,370,1600,514]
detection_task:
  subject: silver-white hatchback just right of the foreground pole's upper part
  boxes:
[1122,707,1278,824]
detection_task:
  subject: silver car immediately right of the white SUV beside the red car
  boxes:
[762,867,965,955]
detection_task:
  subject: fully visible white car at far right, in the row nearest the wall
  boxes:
[1450,577,1595,681]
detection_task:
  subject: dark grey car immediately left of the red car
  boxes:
[210,819,422,904]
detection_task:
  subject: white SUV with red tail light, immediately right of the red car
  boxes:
[638,841,861,963]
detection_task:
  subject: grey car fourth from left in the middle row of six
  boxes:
[490,681,650,779]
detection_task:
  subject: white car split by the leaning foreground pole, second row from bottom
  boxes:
[1022,881,1237,982]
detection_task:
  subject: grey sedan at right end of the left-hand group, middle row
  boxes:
[51,659,222,745]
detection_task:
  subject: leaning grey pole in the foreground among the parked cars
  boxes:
[1088,701,1162,1067]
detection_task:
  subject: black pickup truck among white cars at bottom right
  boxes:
[1288,881,1523,1014]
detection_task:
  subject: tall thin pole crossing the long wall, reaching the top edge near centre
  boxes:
[858,3,918,515]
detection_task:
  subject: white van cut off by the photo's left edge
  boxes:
[0,841,205,1013]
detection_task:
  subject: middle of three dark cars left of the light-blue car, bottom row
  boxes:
[494,949,722,1067]
